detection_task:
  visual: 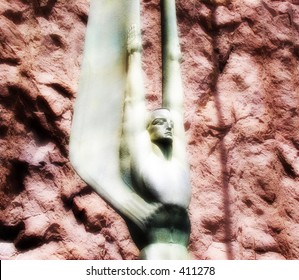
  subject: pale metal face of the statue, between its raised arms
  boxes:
[147,109,173,142]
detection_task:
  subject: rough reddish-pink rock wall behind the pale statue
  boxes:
[0,0,299,259]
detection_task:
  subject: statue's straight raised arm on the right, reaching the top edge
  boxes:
[161,0,188,165]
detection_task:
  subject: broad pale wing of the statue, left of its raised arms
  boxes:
[70,0,153,228]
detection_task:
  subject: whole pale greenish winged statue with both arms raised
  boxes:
[70,0,191,259]
